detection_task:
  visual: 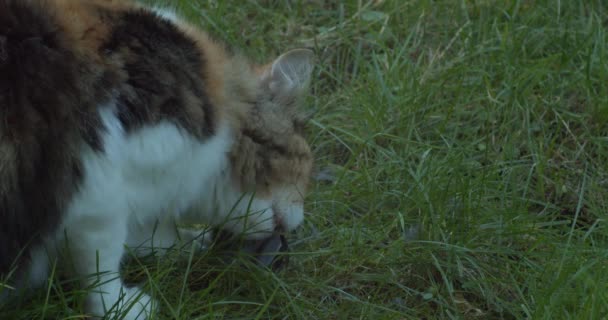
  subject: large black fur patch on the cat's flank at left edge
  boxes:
[0,0,104,274]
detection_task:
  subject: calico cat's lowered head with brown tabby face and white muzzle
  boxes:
[231,49,314,235]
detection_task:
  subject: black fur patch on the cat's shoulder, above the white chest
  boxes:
[101,10,215,139]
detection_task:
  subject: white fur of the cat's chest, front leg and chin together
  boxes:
[42,104,284,320]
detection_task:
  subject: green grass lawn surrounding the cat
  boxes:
[0,0,608,319]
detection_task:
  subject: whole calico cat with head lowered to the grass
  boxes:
[0,0,313,319]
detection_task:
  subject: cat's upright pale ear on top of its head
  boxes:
[263,49,314,98]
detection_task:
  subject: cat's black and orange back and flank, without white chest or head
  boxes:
[0,0,248,274]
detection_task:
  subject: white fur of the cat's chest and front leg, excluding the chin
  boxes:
[52,104,231,319]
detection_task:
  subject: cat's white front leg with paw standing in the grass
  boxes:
[65,212,153,320]
